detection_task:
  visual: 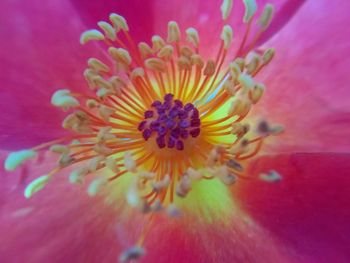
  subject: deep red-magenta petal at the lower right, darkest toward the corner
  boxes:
[238,153,350,263]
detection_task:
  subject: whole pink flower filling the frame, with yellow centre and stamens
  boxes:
[0,0,350,262]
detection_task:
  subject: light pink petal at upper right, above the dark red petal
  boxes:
[256,1,350,152]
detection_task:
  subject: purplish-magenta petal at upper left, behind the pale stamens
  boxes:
[0,0,100,149]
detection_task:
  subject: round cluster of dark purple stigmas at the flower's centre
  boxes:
[138,93,201,151]
